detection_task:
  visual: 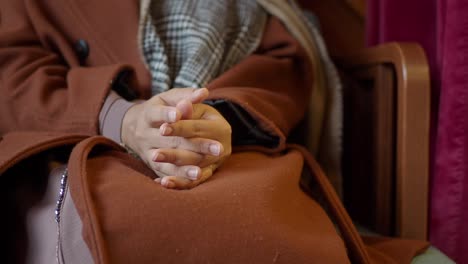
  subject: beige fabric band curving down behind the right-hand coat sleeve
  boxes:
[258,0,343,198]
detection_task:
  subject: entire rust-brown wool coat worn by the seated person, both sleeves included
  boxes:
[0,0,428,263]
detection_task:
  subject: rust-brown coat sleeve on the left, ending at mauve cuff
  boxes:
[0,0,134,135]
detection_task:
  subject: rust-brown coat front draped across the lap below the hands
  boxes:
[71,151,347,263]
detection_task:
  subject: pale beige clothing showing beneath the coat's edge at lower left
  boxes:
[26,166,94,264]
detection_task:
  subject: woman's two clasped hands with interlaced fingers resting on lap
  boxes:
[121,88,231,189]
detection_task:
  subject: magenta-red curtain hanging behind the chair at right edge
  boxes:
[367,0,468,263]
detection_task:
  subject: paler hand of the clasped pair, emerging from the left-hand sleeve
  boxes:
[121,88,222,180]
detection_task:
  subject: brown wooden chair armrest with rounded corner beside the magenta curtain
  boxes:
[335,43,430,239]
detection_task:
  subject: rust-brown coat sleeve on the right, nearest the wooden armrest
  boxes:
[208,18,313,152]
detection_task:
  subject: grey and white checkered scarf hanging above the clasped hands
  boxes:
[141,0,267,95]
